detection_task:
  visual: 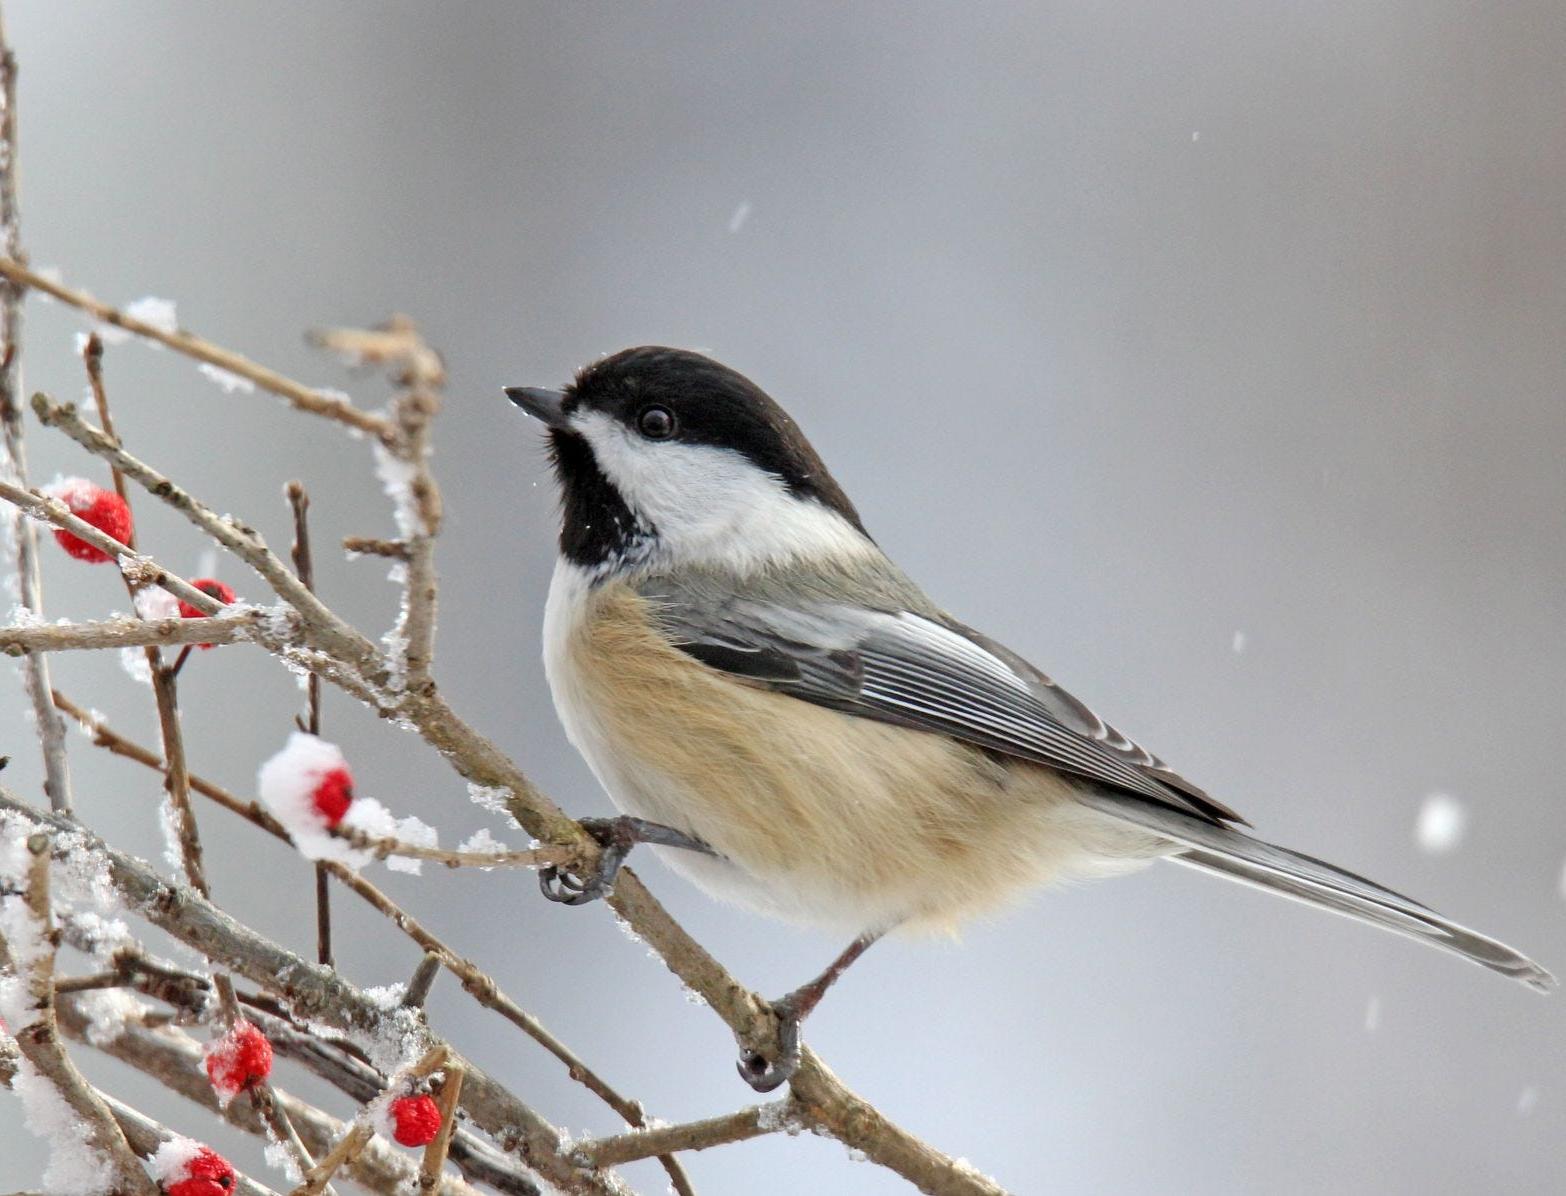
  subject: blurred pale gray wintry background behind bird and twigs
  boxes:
[0,0,1566,1196]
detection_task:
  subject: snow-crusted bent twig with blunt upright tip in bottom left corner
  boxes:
[0,828,157,1196]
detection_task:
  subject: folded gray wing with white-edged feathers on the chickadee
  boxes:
[642,579,1240,822]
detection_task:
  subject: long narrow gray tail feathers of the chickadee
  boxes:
[1081,789,1555,992]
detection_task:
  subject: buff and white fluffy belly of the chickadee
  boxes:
[547,569,1159,933]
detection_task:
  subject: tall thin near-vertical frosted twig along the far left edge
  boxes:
[0,20,70,814]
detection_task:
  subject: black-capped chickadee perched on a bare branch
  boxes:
[504,346,1555,1091]
